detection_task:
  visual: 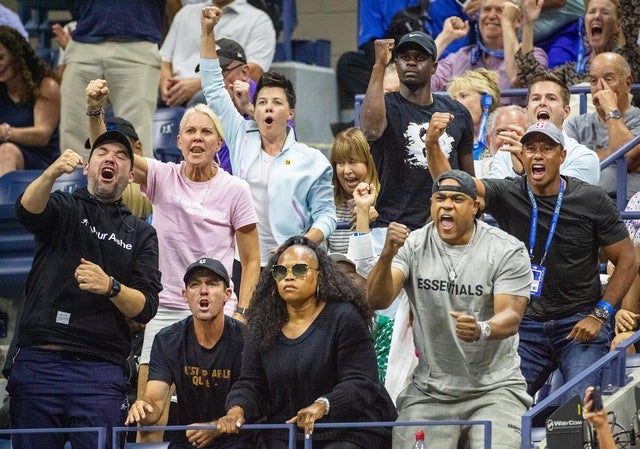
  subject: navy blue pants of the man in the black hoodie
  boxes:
[7,348,128,449]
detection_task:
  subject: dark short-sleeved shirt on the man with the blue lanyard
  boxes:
[483,177,629,321]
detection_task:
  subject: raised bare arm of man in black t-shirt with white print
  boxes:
[360,39,395,141]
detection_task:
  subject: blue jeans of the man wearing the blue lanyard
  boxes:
[518,313,611,398]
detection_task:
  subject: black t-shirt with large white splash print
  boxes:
[371,92,473,229]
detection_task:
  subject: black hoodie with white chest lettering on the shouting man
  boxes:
[16,188,162,366]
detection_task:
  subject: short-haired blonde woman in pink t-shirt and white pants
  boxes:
[87,80,260,441]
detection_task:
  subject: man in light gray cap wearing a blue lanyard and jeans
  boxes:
[426,117,636,402]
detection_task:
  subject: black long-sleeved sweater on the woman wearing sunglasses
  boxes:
[227,301,397,449]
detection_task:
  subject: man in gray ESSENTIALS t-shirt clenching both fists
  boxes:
[367,169,531,449]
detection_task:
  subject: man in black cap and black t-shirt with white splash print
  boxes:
[360,31,474,252]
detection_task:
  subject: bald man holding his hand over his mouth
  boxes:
[565,52,640,200]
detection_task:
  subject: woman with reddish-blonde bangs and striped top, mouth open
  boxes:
[328,128,380,254]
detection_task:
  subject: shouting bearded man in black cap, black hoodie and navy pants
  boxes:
[7,131,162,449]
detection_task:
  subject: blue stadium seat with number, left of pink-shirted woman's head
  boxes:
[153,107,185,163]
